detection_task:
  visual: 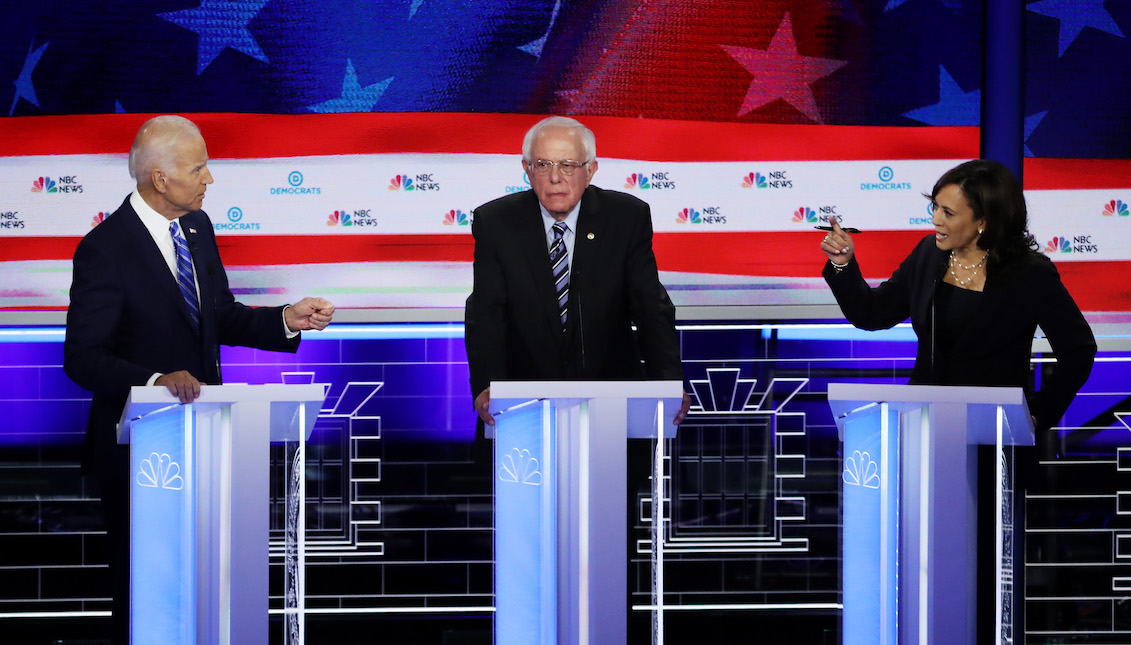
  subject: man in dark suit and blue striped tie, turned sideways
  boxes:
[63,115,334,643]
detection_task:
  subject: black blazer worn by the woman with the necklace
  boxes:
[822,234,1096,430]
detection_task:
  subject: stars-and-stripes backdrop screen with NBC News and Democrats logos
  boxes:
[0,0,1131,311]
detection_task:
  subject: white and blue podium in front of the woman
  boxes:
[829,384,1034,645]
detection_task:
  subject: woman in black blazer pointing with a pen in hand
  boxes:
[821,160,1096,434]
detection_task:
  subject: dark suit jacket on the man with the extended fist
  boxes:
[63,198,299,482]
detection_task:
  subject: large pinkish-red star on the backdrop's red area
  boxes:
[719,14,848,123]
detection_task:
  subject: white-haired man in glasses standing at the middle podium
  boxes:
[465,117,690,425]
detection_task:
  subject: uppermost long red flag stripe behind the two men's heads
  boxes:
[0,112,978,162]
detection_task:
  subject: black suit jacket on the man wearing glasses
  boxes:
[465,186,683,397]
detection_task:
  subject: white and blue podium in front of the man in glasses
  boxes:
[487,381,683,645]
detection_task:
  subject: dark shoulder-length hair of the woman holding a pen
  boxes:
[931,160,1038,269]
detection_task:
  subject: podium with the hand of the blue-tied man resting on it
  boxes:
[118,384,326,645]
